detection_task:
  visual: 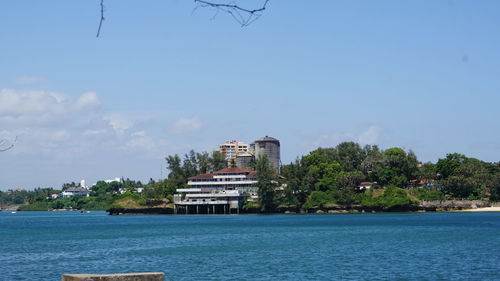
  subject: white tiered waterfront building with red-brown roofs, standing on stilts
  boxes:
[174,168,258,214]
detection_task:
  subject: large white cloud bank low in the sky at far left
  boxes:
[0,89,165,160]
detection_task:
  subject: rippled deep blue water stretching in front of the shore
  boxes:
[0,211,500,281]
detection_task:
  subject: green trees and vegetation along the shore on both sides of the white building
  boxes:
[0,142,500,214]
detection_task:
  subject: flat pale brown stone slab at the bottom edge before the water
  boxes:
[61,272,165,281]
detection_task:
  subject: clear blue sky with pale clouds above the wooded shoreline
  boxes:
[0,0,500,190]
